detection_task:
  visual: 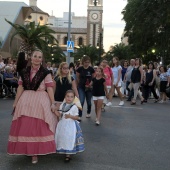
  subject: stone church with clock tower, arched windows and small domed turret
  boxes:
[26,0,103,51]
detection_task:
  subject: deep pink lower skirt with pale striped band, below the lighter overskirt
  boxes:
[7,116,56,156]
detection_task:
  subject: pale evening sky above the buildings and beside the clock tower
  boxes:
[2,0,127,51]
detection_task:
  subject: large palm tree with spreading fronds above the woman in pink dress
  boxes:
[5,19,57,55]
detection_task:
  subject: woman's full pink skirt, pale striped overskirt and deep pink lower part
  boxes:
[7,91,57,156]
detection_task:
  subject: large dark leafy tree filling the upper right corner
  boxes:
[122,0,170,62]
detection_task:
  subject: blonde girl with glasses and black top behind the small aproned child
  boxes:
[54,62,79,113]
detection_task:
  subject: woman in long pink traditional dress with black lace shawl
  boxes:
[7,50,57,163]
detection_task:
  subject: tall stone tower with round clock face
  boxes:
[87,0,103,46]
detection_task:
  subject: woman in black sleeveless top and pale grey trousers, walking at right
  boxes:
[131,58,144,105]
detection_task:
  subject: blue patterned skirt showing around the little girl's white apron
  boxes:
[57,121,85,154]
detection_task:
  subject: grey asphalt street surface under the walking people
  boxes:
[0,97,170,170]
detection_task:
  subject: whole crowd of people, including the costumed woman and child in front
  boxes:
[0,49,170,163]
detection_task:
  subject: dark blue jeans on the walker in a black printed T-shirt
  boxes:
[78,87,92,117]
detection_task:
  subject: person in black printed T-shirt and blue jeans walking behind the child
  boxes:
[76,55,95,120]
